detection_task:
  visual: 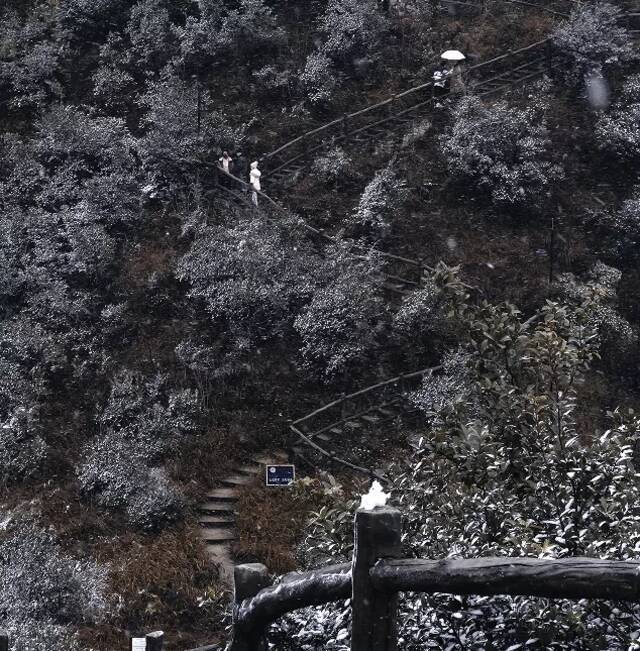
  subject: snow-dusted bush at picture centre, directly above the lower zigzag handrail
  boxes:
[295,248,385,380]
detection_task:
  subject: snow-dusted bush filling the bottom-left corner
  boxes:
[0,511,109,651]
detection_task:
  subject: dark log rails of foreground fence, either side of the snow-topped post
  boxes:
[229,557,640,649]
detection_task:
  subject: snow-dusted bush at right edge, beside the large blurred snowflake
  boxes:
[595,75,640,163]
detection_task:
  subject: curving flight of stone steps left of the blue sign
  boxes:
[198,450,288,585]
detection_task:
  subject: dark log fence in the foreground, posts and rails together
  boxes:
[227,507,640,651]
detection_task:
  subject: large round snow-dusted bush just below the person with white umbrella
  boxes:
[440,96,562,209]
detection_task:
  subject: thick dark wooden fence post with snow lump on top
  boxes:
[351,506,401,651]
